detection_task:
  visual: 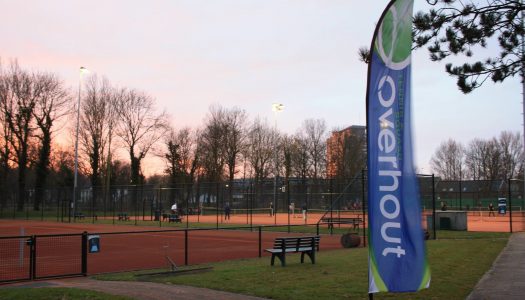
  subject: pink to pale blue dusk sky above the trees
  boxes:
[0,0,523,174]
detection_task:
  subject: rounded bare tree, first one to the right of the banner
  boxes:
[430,139,465,180]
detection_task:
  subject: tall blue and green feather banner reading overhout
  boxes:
[367,0,430,293]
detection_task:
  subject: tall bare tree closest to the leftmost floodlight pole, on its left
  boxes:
[33,74,71,210]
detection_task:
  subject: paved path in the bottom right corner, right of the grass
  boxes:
[467,232,525,300]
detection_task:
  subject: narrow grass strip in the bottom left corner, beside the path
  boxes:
[0,287,131,300]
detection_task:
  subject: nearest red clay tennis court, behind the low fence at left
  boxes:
[0,216,341,281]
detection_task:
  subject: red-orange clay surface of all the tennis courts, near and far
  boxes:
[0,212,525,281]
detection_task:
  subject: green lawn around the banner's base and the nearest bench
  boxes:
[97,238,507,299]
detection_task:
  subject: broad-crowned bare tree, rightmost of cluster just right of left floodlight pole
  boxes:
[116,90,167,185]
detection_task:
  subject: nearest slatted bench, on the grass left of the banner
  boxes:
[264,235,320,267]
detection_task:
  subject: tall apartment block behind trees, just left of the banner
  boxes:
[326,125,366,178]
